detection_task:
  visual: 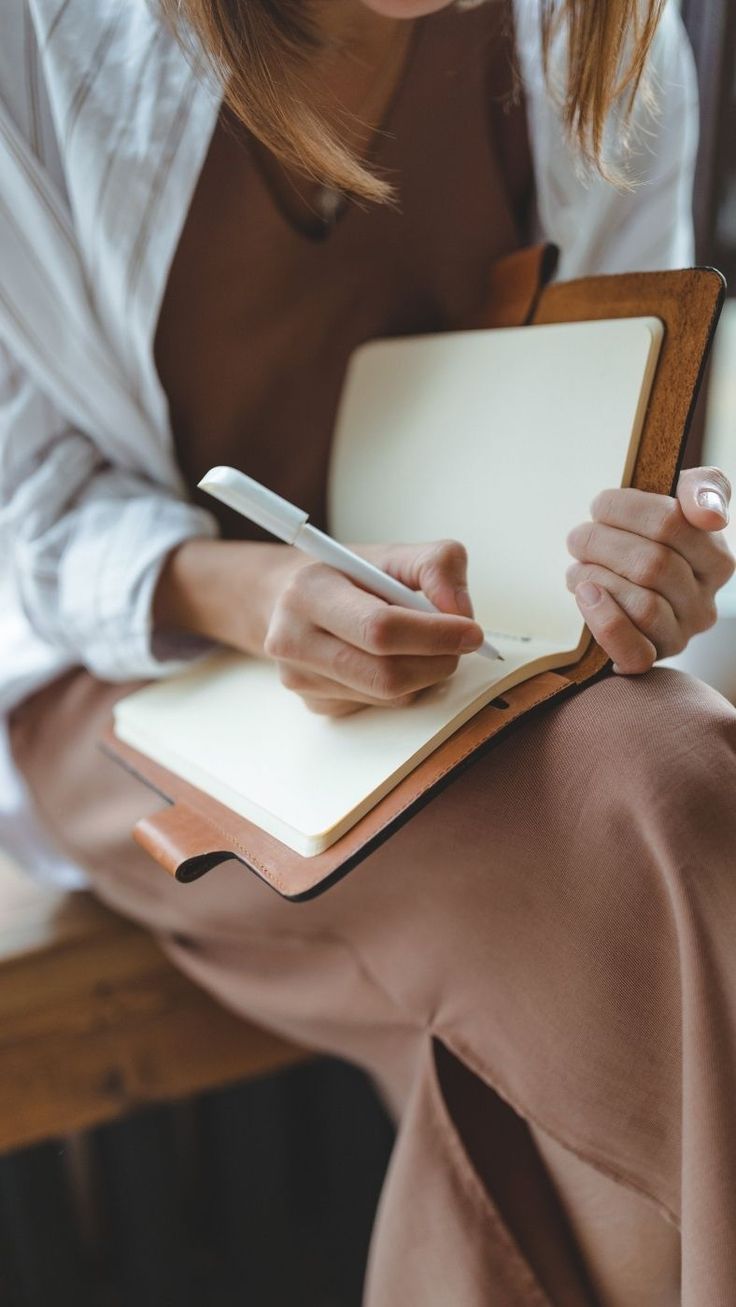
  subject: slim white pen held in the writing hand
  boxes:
[199,468,503,661]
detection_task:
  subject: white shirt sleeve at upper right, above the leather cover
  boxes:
[516,0,698,280]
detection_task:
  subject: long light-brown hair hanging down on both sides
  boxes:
[161,0,665,200]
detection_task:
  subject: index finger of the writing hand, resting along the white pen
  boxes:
[303,567,484,655]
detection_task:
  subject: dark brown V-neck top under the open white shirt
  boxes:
[156,4,532,538]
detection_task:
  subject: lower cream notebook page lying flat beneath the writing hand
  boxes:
[114,642,554,857]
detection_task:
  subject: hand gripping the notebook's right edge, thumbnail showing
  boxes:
[567,468,736,676]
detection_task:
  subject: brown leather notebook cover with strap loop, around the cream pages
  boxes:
[102,246,724,901]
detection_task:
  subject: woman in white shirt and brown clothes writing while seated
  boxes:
[0,0,736,1307]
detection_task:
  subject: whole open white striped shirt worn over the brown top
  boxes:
[0,0,697,884]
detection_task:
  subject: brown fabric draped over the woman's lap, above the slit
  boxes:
[13,669,736,1286]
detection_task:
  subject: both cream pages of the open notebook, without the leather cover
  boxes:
[114,318,663,857]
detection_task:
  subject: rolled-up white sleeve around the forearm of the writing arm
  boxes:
[0,344,217,681]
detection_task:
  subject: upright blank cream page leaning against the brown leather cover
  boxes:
[329,318,664,648]
